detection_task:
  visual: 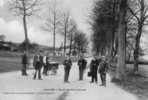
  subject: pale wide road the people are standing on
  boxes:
[0,59,138,100]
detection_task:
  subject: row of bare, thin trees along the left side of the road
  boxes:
[10,0,87,55]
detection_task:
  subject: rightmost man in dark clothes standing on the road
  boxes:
[99,56,108,86]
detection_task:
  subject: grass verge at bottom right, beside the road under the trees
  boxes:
[111,69,148,100]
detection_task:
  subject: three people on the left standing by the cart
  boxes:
[22,52,54,80]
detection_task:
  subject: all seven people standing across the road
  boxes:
[22,53,108,86]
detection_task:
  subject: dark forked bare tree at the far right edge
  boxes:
[128,0,148,73]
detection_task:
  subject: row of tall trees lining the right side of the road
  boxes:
[91,0,148,80]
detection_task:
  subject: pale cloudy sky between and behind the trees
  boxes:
[0,0,93,46]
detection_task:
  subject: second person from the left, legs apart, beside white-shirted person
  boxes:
[33,54,43,80]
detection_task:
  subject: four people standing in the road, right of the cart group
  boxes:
[63,56,109,86]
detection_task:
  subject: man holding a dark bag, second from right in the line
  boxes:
[90,56,100,83]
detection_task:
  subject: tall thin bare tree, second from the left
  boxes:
[42,0,62,55]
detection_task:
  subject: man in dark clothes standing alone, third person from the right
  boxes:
[78,56,87,80]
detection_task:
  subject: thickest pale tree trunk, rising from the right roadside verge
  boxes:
[116,0,127,80]
